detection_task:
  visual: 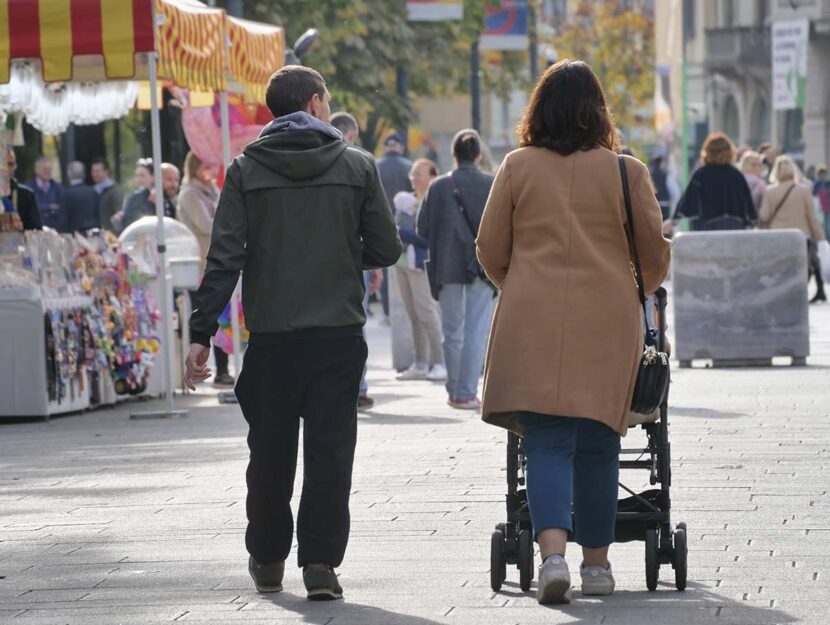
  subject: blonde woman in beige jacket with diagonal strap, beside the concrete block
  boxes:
[761,156,827,304]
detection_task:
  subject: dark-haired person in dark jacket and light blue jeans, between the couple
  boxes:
[418,129,495,410]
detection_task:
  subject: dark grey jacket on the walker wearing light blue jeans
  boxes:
[418,164,493,287]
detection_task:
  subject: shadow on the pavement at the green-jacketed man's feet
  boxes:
[262,593,448,625]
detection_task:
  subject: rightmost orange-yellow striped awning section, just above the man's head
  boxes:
[227,17,285,103]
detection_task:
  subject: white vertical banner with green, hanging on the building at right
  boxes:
[772,20,810,111]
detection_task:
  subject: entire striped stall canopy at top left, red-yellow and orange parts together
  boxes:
[0,0,285,102]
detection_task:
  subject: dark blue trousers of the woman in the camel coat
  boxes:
[519,412,620,549]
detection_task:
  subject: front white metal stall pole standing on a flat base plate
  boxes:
[130,48,187,419]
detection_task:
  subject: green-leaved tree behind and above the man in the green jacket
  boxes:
[250,0,527,151]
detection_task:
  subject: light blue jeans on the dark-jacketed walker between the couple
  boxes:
[438,278,495,401]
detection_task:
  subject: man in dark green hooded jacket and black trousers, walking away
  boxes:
[185,65,401,599]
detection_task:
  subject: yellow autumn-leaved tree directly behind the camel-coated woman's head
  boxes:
[554,0,654,154]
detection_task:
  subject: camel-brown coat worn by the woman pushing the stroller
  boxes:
[477,147,671,434]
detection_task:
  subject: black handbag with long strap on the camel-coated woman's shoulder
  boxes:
[617,156,671,414]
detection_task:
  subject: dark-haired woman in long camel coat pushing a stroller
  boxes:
[477,60,670,603]
